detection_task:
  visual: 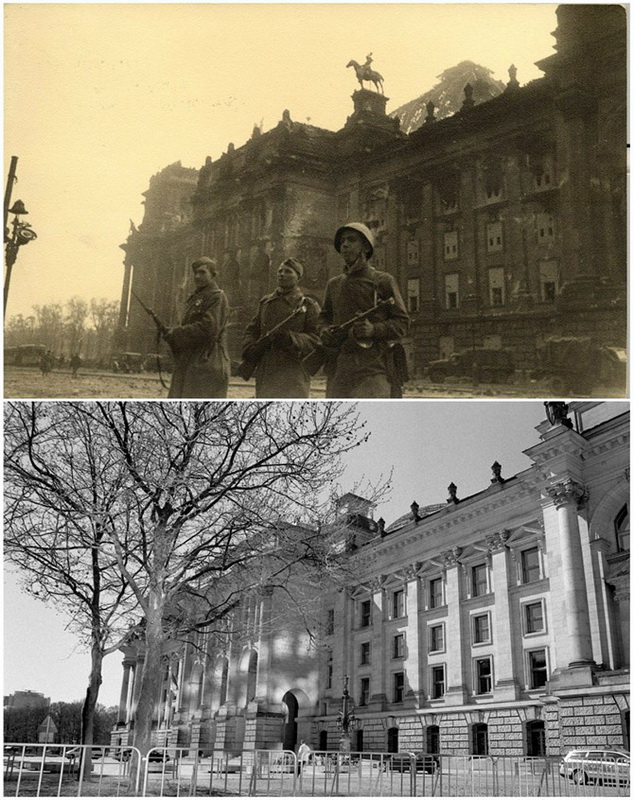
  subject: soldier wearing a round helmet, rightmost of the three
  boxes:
[319,222,409,398]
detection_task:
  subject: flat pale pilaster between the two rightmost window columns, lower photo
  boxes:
[487,531,518,700]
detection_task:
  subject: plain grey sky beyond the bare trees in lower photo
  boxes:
[4,400,552,705]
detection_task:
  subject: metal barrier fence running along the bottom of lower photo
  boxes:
[4,744,630,797]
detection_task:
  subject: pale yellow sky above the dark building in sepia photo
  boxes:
[4,2,556,316]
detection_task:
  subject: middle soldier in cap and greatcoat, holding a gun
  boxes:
[242,258,319,398]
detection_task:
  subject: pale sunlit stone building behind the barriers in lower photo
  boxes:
[112,401,630,756]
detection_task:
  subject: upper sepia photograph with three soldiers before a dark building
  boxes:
[4,3,627,399]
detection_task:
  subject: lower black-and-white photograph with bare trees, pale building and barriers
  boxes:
[4,400,630,797]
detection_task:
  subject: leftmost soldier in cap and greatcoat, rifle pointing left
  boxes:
[163,256,230,398]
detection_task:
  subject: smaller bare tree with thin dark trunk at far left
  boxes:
[4,403,138,776]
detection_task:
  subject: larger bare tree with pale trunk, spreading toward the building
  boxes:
[6,402,380,776]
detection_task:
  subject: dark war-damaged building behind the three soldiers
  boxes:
[121,4,627,394]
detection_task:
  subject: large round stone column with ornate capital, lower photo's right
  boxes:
[546,478,594,668]
